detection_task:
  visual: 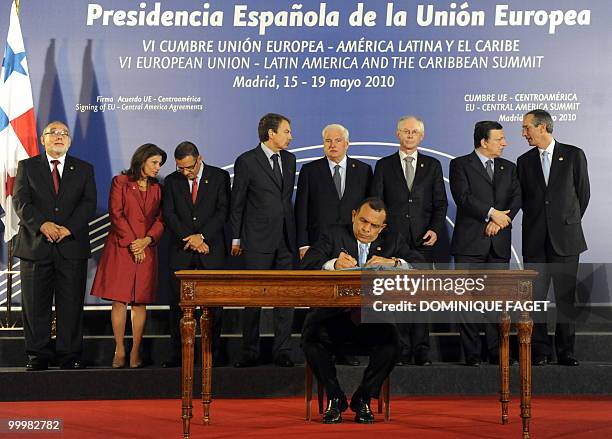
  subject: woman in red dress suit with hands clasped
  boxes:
[91,143,167,368]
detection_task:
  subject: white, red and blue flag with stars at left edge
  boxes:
[0,2,38,241]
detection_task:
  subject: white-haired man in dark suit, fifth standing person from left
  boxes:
[295,124,372,366]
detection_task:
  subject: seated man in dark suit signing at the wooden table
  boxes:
[301,198,422,424]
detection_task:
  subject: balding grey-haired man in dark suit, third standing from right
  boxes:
[371,116,448,366]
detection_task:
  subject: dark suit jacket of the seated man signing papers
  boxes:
[300,225,424,331]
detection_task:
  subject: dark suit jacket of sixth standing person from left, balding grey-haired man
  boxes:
[371,152,448,247]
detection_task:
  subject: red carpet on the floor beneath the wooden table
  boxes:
[0,397,612,439]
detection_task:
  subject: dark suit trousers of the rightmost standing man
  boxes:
[523,234,580,359]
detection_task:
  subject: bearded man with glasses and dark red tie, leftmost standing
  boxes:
[13,122,96,370]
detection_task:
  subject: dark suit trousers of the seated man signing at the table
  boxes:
[302,311,400,399]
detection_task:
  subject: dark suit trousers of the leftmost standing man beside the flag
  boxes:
[21,245,87,363]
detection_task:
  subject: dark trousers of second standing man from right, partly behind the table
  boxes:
[455,246,510,361]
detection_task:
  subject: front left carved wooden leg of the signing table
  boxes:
[181,306,196,439]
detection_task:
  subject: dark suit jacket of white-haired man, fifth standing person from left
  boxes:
[295,157,372,247]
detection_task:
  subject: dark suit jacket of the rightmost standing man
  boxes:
[517,142,590,257]
